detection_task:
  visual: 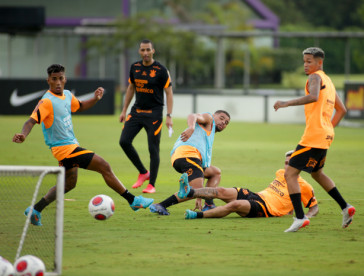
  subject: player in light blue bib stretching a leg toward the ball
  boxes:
[13,64,153,226]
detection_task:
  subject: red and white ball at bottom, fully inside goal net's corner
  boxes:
[14,255,45,276]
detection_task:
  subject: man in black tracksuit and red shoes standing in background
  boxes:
[119,40,173,193]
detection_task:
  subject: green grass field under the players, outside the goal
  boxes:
[0,116,364,276]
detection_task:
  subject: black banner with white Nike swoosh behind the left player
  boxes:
[0,79,115,115]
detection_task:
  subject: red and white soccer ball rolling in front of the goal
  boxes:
[88,195,115,220]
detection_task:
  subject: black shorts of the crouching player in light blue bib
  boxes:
[173,157,204,182]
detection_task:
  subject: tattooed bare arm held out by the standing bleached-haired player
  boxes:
[273,74,321,111]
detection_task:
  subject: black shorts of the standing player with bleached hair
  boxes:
[289,145,327,173]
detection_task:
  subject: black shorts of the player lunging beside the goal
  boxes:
[58,147,95,170]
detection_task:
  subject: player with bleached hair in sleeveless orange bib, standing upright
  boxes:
[274,47,355,232]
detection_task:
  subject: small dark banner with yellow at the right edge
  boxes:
[345,82,364,119]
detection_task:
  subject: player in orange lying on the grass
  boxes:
[178,151,318,219]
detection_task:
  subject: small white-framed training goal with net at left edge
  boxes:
[0,166,64,275]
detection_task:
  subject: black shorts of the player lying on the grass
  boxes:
[234,187,273,218]
